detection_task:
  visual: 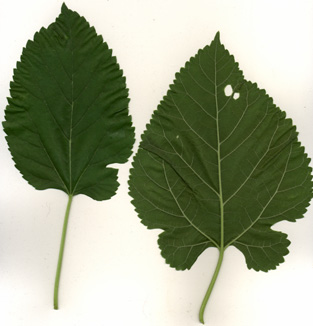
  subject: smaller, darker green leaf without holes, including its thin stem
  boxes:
[3,4,134,306]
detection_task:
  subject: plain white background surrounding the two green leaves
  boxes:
[0,0,313,326]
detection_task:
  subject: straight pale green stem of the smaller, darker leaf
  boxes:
[53,195,73,310]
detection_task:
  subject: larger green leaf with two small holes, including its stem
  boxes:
[129,34,312,322]
